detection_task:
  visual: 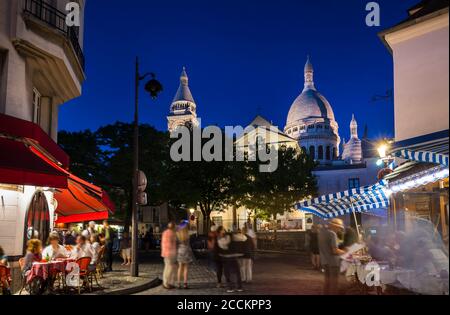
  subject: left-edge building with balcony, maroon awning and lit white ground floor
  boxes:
[0,0,85,260]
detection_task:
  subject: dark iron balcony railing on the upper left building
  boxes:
[24,0,85,70]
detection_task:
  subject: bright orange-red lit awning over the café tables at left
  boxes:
[54,174,114,224]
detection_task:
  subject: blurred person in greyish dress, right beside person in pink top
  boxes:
[177,223,194,289]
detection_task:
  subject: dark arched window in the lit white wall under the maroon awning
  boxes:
[24,191,50,253]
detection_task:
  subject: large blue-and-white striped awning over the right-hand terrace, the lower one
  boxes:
[295,181,389,219]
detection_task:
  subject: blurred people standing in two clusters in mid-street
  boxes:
[161,222,256,293]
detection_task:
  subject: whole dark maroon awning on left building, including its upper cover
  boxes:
[0,114,69,188]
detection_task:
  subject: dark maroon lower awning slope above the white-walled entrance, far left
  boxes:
[0,137,67,188]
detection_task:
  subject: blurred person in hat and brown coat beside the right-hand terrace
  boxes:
[319,219,345,295]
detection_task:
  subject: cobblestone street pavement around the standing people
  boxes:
[135,253,354,295]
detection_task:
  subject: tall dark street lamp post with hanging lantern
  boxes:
[131,57,163,277]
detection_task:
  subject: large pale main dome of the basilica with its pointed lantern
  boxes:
[286,57,335,127]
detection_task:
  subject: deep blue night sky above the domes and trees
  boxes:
[60,0,418,138]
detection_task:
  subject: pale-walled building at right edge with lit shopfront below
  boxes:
[380,0,449,244]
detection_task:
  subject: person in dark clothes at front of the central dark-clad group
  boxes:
[217,229,244,293]
